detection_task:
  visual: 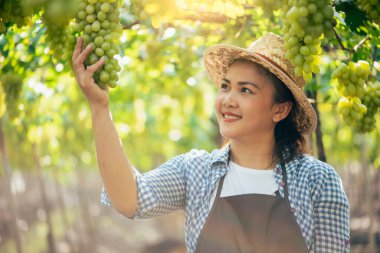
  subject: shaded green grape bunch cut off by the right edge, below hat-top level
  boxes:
[353,81,380,133]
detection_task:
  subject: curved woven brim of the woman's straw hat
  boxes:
[203,44,317,134]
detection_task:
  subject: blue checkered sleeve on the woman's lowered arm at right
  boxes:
[312,164,350,253]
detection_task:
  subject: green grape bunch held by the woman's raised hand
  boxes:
[76,0,122,88]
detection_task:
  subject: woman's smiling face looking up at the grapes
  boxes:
[215,61,276,140]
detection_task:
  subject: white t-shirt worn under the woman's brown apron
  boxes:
[210,161,278,209]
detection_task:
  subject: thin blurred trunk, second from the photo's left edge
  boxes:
[33,144,56,253]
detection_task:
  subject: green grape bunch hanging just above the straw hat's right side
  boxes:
[283,0,334,81]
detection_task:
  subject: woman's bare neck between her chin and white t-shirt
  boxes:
[230,134,276,170]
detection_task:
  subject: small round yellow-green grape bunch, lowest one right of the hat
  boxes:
[338,97,367,125]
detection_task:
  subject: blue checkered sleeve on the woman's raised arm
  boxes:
[101,155,187,219]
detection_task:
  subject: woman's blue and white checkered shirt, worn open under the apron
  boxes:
[101,146,350,253]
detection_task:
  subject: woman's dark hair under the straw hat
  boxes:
[234,59,305,163]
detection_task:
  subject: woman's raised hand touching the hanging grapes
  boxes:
[72,38,109,110]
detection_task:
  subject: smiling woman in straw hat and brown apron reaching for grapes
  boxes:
[73,34,349,253]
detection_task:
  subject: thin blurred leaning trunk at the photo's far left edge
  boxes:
[0,118,23,253]
